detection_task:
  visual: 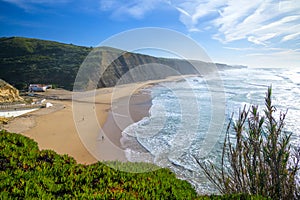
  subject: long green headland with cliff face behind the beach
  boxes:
[0,37,241,90]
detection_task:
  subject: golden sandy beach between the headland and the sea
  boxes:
[4,77,195,164]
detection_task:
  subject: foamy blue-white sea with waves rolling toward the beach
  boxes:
[121,68,300,194]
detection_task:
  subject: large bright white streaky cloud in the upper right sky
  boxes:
[171,0,300,45]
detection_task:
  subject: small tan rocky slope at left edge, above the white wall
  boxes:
[0,79,23,103]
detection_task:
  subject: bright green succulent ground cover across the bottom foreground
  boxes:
[0,131,264,200]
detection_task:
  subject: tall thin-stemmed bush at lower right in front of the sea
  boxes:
[197,87,300,199]
